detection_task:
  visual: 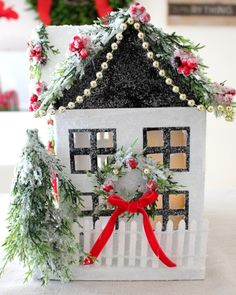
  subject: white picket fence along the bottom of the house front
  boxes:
[73,217,208,280]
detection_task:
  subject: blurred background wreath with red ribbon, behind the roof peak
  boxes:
[26,0,131,25]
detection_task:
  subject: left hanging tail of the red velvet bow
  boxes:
[83,208,125,265]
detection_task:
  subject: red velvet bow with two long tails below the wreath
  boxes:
[83,190,176,267]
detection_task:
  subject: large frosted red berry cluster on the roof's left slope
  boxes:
[69,36,90,59]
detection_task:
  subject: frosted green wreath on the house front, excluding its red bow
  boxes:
[90,145,180,217]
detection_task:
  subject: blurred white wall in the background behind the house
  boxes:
[0,0,236,192]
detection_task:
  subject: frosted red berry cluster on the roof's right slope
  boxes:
[174,49,198,76]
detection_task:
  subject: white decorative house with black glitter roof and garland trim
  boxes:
[27,4,233,280]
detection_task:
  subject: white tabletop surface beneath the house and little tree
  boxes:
[0,191,236,295]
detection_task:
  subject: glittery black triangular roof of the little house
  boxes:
[56,28,197,109]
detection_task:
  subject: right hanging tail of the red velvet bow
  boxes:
[139,209,176,267]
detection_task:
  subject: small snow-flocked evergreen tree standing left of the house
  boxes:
[1,130,83,285]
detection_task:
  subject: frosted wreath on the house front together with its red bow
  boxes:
[83,147,178,267]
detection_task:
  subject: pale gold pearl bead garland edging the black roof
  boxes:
[45,17,223,118]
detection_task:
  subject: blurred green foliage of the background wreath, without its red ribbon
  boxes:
[26,0,131,25]
